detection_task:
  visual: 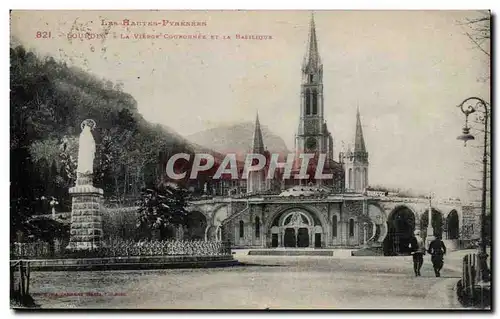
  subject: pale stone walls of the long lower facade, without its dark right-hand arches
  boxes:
[190,194,462,249]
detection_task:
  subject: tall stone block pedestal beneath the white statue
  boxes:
[67,174,104,250]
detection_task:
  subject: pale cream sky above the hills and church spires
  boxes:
[11,11,490,199]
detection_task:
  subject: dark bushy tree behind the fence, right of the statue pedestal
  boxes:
[137,184,188,239]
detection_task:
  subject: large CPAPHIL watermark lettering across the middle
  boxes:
[166,153,333,180]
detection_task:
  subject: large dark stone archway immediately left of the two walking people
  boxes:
[384,206,416,256]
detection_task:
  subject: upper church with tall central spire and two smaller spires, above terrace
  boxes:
[246,17,368,200]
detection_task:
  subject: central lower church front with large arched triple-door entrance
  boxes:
[223,205,377,249]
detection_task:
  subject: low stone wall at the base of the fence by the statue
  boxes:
[11,255,238,271]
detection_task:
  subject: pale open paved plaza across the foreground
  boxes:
[30,255,460,309]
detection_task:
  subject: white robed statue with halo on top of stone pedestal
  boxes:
[76,120,96,174]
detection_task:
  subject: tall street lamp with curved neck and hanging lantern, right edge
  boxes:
[457,97,490,282]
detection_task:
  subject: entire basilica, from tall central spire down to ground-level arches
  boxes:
[184,17,462,254]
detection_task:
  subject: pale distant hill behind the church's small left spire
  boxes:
[186,122,289,160]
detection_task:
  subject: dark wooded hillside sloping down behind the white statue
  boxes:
[10,44,205,212]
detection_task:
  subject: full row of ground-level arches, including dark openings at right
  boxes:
[187,204,459,250]
